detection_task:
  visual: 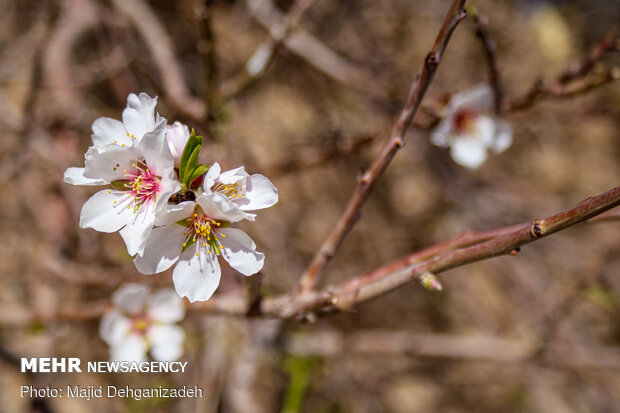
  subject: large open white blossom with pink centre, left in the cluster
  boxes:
[65,118,180,255]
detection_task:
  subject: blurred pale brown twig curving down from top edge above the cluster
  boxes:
[112,0,207,121]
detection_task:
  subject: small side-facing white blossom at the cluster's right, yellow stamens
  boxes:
[203,162,278,221]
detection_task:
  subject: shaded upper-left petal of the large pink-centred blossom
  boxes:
[84,145,137,182]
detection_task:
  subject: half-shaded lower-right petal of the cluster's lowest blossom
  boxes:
[217,228,265,275]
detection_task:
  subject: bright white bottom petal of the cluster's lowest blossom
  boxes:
[172,243,221,303]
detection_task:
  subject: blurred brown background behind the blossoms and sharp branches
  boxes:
[0,0,620,413]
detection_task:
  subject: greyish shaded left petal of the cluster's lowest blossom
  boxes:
[134,223,185,275]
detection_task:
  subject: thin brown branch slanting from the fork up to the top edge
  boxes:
[300,0,466,294]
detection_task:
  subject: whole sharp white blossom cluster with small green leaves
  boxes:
[64,93,278,302]
